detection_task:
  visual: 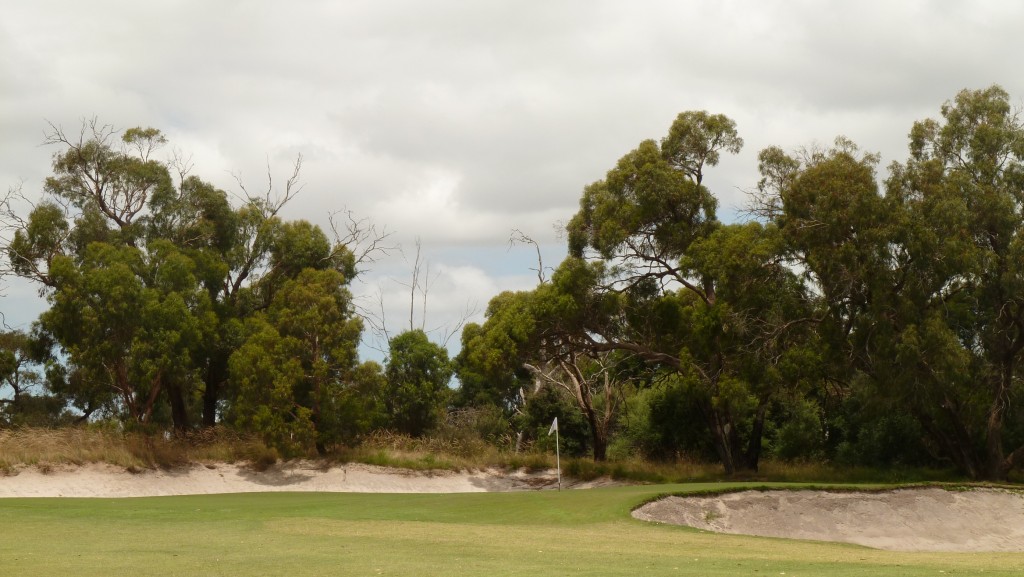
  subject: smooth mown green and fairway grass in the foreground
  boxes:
[0,485,1024,577]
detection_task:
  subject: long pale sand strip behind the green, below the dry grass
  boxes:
[0,462,610,497]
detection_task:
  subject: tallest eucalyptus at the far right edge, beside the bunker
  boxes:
[887,86,1024,480]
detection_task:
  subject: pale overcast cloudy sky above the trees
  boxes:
[0,0,1024,359]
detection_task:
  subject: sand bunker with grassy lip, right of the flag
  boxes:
[633,488,1024,551]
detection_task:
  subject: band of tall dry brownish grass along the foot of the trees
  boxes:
[0,426,962,483]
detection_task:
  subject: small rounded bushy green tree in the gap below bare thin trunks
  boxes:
[383,329,454,437]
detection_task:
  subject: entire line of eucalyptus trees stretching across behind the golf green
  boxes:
[6,86,1024,480]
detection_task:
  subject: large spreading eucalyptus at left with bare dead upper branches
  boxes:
[0,120,366,428]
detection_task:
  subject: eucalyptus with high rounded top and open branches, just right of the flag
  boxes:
[563,112,807,473]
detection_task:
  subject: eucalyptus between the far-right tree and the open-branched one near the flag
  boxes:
[754,137,914,469]
